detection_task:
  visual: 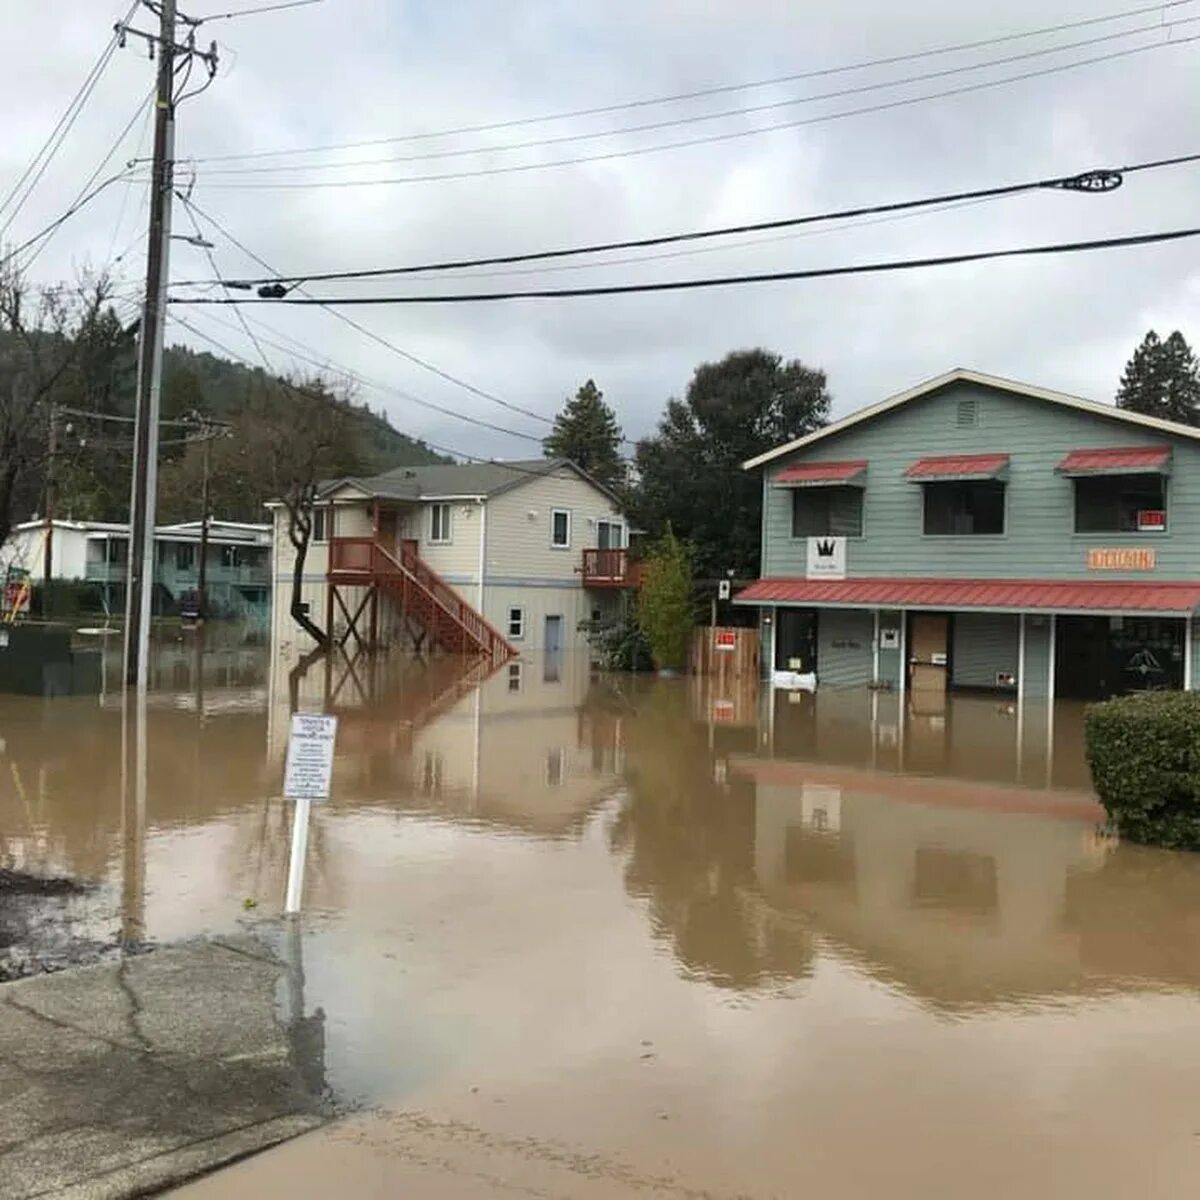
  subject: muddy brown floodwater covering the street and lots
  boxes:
[0,650,1200,1200]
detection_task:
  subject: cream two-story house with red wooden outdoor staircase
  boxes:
[270,458,634,656]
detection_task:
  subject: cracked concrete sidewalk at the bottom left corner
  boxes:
[0,938,324,1200]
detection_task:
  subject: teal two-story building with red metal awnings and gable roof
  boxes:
[737,370,1200,700]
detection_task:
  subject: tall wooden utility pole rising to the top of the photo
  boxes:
[118,0,217,691]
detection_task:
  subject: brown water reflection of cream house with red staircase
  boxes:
[269,653,623,834]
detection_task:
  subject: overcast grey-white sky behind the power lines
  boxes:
[0,0,1200,457]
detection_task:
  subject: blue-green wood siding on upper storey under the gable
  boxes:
[762,382,1200,580]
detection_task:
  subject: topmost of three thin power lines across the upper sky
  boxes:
[180,0,1195,162]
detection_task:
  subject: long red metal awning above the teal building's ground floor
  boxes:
[736,577,1200,617]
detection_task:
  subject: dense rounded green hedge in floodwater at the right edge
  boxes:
[1085,691,1200,850]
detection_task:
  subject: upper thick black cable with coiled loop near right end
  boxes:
[174,152,1200,288]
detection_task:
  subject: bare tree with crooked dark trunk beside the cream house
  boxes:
[234,376,358,647]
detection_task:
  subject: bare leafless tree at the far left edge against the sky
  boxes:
[0,265,108,545]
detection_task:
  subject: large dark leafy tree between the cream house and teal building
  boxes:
[632,349,829,578]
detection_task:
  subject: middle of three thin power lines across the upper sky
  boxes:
[184,17,1200,178]
